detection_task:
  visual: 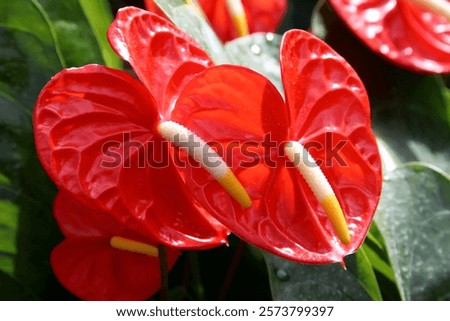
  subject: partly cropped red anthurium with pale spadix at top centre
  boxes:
[145,0,287,42]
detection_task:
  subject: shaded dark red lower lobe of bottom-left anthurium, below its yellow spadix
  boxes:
[50,238,179,300]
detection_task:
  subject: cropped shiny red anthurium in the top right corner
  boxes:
[330,0,450,73]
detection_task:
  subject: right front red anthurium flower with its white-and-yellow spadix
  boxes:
[172,30,381,264]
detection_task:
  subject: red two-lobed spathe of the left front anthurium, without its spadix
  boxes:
[33,8,234,248]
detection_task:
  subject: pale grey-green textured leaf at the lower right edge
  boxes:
[375,163,450,300]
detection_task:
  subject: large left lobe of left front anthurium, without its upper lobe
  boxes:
[33,65,227,248]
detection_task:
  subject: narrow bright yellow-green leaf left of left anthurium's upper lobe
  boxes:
[78,0,122,69]
